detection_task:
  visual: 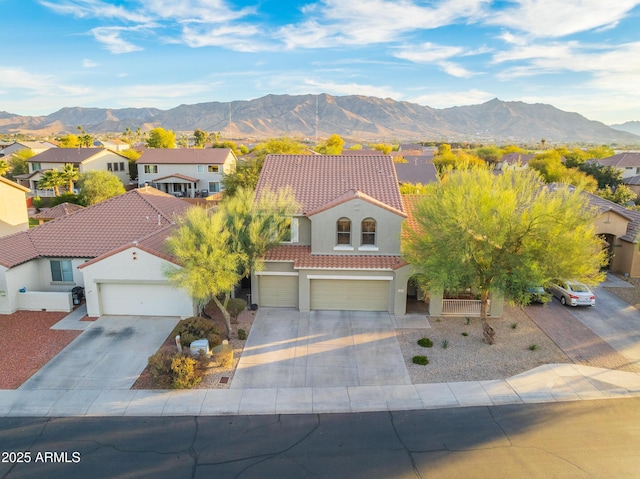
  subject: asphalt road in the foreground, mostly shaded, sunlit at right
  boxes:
[0,398,640,479]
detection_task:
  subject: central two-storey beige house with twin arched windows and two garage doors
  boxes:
[251,155,411,315]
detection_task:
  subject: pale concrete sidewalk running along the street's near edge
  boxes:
[0,364,640,417]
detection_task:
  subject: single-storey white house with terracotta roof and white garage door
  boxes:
[0,188,196,317]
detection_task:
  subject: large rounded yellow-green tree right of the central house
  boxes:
[404,169,605,344]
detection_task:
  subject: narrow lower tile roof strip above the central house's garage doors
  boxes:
[265,245,407,270]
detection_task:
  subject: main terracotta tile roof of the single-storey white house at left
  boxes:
[0,188,189,268]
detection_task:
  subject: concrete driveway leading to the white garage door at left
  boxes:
[19,316,179,390]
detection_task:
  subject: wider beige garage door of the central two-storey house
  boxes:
[311,279,389,311]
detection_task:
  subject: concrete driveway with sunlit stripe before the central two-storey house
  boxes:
[231,308,411,389]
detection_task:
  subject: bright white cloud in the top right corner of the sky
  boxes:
[484,0,640,37]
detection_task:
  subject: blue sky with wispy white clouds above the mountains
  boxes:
[0,0,640,124]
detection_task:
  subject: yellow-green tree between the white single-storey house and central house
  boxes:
[165,189,298,338]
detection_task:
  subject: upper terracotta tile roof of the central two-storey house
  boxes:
[256,155,403,215]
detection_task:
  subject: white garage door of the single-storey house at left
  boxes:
[100,283,193,316]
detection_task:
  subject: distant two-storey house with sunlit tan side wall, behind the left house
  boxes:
[16,148,129,190]
